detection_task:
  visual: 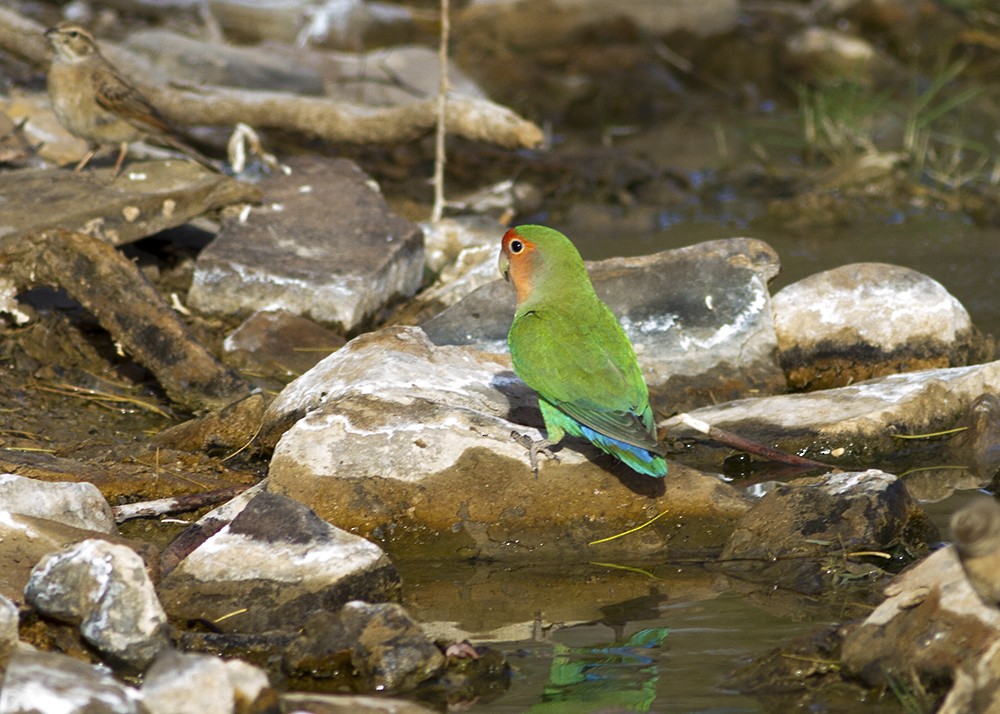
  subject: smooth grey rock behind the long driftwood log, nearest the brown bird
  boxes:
[125,30,324,96]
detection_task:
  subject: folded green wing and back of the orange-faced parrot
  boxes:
[508,298,659,453]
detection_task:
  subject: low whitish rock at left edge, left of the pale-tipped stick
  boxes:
[0,474,118,533]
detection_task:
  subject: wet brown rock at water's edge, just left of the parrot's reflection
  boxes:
[284,602,445,692]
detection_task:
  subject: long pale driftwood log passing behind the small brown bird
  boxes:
[0,9,544,148]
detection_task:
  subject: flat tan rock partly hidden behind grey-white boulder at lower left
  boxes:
[0,511,159,605]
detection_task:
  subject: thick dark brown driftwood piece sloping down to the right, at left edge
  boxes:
[0,230,250,411]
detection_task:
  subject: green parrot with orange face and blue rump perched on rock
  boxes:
[499,226,667,477]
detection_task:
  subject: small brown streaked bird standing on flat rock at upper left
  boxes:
[45,22,219,176]
